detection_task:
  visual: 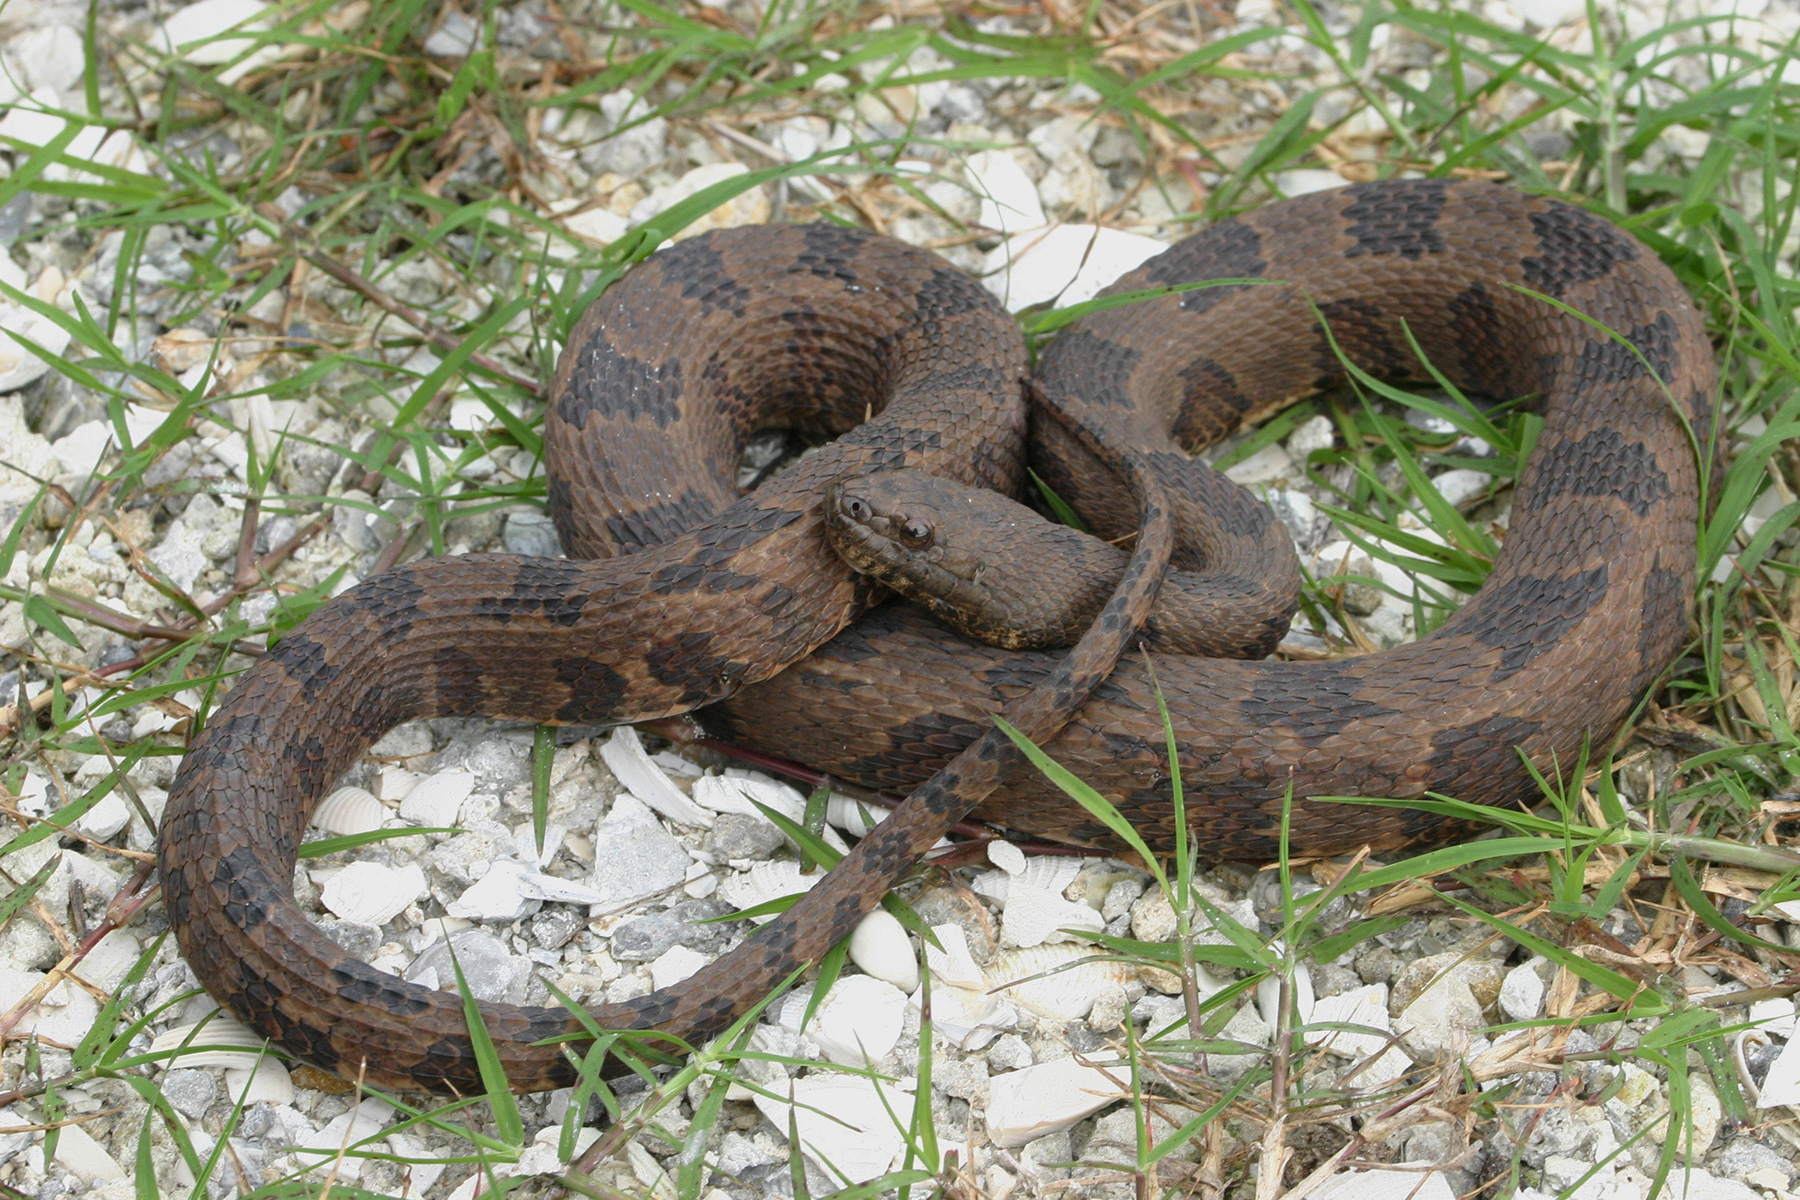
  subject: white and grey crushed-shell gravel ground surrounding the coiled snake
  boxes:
[0,0,1800,1200]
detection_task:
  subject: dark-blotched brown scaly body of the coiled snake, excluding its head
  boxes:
[160,180,1715,1092]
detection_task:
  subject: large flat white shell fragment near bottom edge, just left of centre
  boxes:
[752,1074,913,1184]
